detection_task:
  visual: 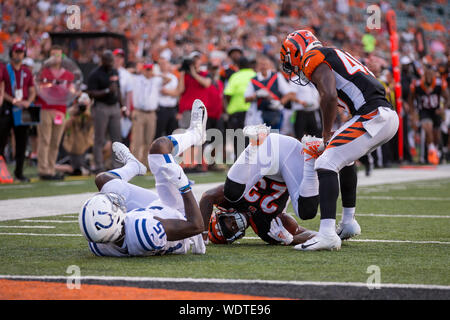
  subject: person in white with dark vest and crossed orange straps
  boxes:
[244,56,295,129]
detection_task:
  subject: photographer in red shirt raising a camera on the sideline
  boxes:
[177,51,211,129]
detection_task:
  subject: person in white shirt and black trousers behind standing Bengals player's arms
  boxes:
[289,82,322,139]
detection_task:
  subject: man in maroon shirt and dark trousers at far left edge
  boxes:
[0,42,36,182]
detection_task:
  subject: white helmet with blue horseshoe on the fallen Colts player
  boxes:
[78,192,127,242]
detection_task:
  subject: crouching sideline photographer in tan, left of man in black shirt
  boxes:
[59,93,94,175]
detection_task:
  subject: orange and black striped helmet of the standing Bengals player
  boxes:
[280,30,322,85]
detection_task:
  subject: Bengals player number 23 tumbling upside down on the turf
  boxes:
[200,125,323,249]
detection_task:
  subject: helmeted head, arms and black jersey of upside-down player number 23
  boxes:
[200,177,315,245]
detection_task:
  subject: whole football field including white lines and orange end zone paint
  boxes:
[0,165,450,300]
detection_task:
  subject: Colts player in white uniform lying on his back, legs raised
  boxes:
[78,100,207,257]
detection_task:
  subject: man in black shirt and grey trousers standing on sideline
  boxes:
[87,50,126,173]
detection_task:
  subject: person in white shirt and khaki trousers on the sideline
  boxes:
[130,64,170,163]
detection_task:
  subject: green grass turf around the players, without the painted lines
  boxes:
[0,179,450,285]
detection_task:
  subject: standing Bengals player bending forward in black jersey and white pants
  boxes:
[280,30,399,250]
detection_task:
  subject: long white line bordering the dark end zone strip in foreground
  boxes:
[0,275,450,290]
